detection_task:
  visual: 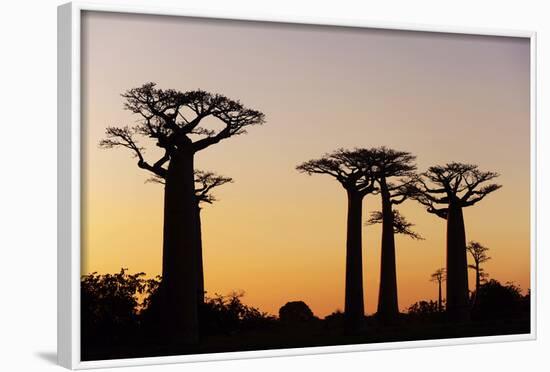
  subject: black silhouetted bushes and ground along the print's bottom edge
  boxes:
[81,269,530,360]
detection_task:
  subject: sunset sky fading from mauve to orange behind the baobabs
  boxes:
[82,12,530,316]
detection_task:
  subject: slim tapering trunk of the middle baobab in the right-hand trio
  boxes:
[377,180,399,321]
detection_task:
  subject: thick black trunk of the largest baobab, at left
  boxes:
[161,151,198,344]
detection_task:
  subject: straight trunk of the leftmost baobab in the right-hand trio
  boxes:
[344,191,365,332]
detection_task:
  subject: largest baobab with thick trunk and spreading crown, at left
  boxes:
[100,83,264,343]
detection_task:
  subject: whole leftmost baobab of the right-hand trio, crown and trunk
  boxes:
[296,149,376,331]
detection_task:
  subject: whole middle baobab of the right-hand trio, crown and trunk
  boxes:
[372,147,416,321]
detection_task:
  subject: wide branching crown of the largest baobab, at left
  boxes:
[99,83,264,177]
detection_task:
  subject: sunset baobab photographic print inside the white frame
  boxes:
[79,11,532,361]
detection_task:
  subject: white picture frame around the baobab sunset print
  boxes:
[57,2,537,369]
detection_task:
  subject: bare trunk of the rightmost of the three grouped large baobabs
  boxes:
[447,202,470,321]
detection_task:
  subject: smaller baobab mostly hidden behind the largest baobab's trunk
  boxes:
[148,170,233,305]
